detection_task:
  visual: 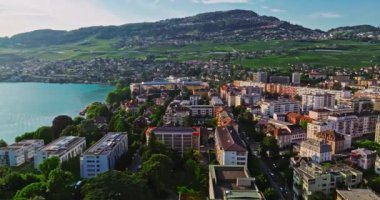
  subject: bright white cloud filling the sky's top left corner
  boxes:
[0,0,126,36]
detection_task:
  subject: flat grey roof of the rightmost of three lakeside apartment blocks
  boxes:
[83,132,127,155]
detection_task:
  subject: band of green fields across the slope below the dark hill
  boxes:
[0,39,380,68]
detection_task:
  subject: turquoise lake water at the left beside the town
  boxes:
[0,83,113,143]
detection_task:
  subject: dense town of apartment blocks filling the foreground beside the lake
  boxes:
[0,68,380,200]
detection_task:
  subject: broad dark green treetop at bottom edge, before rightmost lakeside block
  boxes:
[82,170,153,200]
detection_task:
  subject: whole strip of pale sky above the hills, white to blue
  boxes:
[0,0,380,36]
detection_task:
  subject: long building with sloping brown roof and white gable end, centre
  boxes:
[215,126,248,165]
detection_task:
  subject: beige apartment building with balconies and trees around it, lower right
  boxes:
[293,161,363,200]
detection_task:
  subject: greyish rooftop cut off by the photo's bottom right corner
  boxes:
[336,188,380,200]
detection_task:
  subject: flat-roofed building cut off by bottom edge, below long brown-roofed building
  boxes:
[208,165,264,200]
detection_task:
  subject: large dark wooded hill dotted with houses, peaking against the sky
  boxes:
[0,10,324,48]
